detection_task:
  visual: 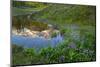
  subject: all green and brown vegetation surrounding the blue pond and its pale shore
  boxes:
[12,1,96,65]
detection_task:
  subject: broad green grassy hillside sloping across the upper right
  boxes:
[33,4,96,26]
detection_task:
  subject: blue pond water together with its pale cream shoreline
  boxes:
[11,29,63,49]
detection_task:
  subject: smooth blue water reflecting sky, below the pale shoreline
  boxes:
[11,34,63,49]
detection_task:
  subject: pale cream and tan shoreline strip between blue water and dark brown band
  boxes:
[12,28,60,39]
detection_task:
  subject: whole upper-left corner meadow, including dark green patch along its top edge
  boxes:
[12,1,47,16]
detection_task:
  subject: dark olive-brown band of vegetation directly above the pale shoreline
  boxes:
[12,15,48,31]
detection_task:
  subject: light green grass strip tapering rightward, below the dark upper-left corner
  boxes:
[12,6,48,16]
